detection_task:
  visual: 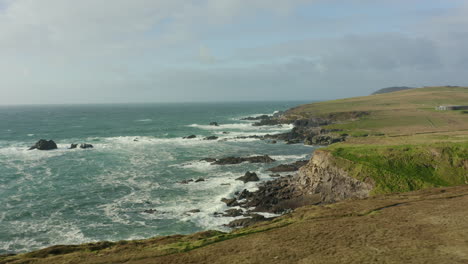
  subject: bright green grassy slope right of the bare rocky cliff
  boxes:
[325,142,468,194]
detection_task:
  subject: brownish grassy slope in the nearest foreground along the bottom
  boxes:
[5,186,468,264]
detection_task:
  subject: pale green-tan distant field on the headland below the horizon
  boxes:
[288,87,468,136]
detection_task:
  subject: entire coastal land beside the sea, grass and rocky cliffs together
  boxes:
[0,87,468,264]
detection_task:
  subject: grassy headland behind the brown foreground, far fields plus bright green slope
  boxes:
[288,87,468,194]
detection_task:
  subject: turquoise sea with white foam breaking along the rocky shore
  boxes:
[0,102,313,254]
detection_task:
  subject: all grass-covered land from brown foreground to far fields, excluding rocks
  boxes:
[0,87,468,263]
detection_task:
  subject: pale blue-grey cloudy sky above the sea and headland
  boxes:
[0,0,468,105]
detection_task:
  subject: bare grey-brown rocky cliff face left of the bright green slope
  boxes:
[238,150,374,213]
